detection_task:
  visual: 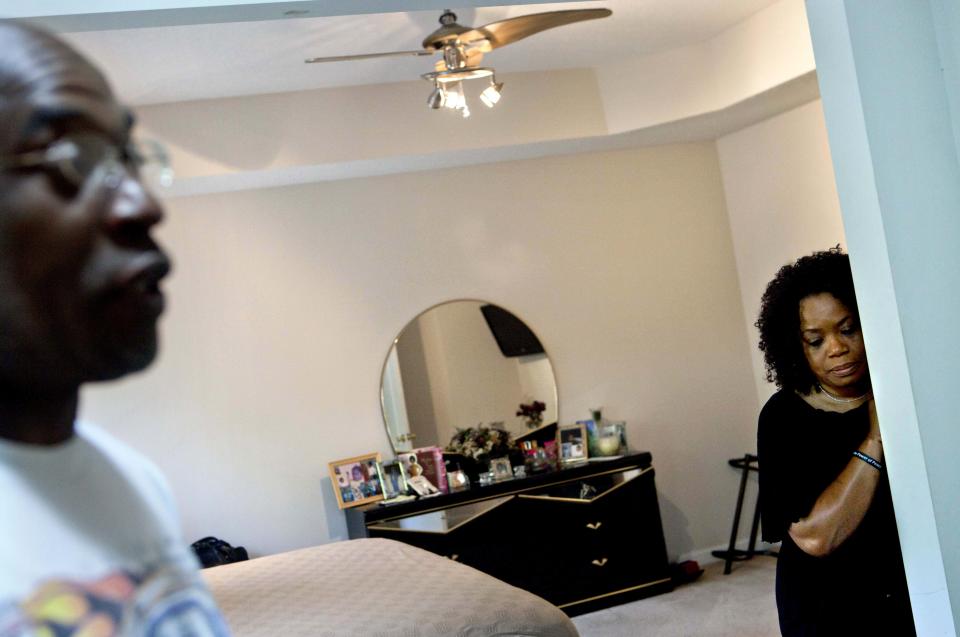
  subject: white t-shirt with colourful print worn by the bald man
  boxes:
[0,423,229,637]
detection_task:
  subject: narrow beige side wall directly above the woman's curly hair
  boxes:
[717,100,845,404]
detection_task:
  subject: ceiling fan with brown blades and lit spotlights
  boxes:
[304,9,613,117]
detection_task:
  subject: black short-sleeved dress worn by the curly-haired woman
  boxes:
[757,390,915,637]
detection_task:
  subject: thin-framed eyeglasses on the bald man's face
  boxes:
[0,133,173,190]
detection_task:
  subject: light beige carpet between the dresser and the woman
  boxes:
[573,556,780,637]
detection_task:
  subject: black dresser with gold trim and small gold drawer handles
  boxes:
[345,452,672,615]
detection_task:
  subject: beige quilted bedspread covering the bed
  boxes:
[203,539,577,637]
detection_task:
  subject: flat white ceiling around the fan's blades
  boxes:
[58,0,776,105]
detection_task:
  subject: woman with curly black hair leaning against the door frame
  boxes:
[756,247,915,637]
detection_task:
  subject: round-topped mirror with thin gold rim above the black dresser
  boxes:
[380,301,557,453]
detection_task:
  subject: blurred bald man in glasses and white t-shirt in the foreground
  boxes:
[0,22,227,637]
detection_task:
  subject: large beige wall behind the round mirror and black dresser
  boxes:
[83,143,757,557]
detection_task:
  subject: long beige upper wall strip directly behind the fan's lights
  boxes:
[137,69,607,180]
